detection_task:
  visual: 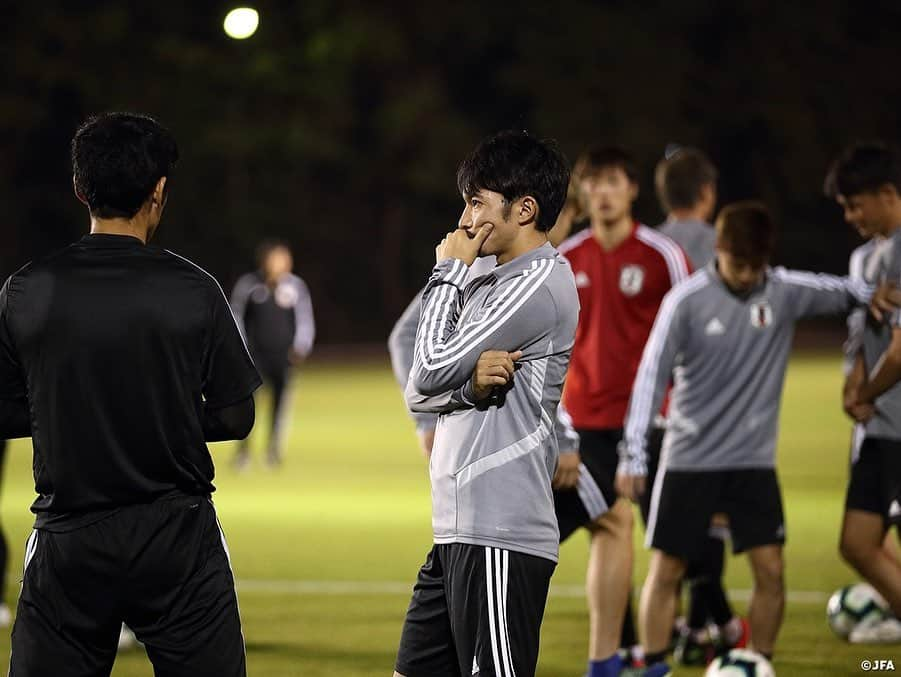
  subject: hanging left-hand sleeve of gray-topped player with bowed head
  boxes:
[617,291,687,476]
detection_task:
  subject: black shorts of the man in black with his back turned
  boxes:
[9,496,247,677]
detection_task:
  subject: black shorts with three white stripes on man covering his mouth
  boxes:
[395,543,556,677]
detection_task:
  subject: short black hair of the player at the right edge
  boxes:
[823,141,901,198]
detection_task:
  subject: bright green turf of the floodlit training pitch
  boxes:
[0,355,888,677]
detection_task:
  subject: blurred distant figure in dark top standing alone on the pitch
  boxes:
[231,240,316,469]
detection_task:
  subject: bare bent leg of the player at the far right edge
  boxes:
[839,510,901,616]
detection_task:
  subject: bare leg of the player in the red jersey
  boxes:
[585,499,633,661]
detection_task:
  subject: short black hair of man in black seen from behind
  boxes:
[72,113,178,219]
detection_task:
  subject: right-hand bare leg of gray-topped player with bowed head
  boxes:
[748,545,785,656]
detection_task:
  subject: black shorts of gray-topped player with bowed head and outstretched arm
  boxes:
[646,468,785,561]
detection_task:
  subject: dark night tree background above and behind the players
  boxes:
[0,0,901,343]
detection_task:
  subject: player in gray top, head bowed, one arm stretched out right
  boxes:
[617,202,872,676]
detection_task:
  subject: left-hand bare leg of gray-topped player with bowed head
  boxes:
[638,550,685,655]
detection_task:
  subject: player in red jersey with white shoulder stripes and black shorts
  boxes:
[555,148,689,677]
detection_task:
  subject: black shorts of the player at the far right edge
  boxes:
[845,437,901,526]
